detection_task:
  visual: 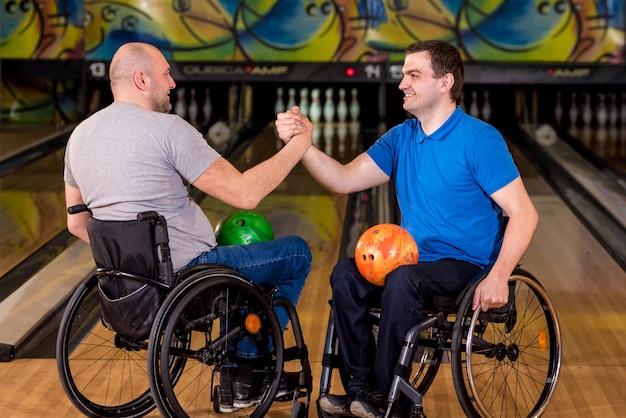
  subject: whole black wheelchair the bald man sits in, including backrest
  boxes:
[56,205,312,418]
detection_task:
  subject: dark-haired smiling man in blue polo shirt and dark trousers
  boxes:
[276,41,538,417]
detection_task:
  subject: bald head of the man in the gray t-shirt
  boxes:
[109,42,176,112]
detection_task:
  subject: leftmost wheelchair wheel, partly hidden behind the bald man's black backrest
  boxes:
[56,276,154,417]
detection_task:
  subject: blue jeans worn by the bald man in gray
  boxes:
[188,235,313,357]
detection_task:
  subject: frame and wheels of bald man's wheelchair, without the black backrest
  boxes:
[57,209,312,418]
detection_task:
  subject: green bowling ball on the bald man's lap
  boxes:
[215,210,274,245]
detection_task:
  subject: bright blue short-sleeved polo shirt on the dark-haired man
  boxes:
[367,107,519,267]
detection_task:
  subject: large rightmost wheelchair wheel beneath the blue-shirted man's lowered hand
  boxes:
[451,268,561,417]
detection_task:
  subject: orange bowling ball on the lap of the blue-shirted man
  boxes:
[354,224,419,286]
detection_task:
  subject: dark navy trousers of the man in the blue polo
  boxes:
[330,258,482,394]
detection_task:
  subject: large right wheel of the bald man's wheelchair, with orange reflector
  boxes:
[148,268,283,417]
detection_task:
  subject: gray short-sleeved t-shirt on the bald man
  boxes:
[64,103,220,270]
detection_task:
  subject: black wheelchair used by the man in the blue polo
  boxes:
[317,266,561,418]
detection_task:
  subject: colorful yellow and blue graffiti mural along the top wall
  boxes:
[0,0,624,63]
